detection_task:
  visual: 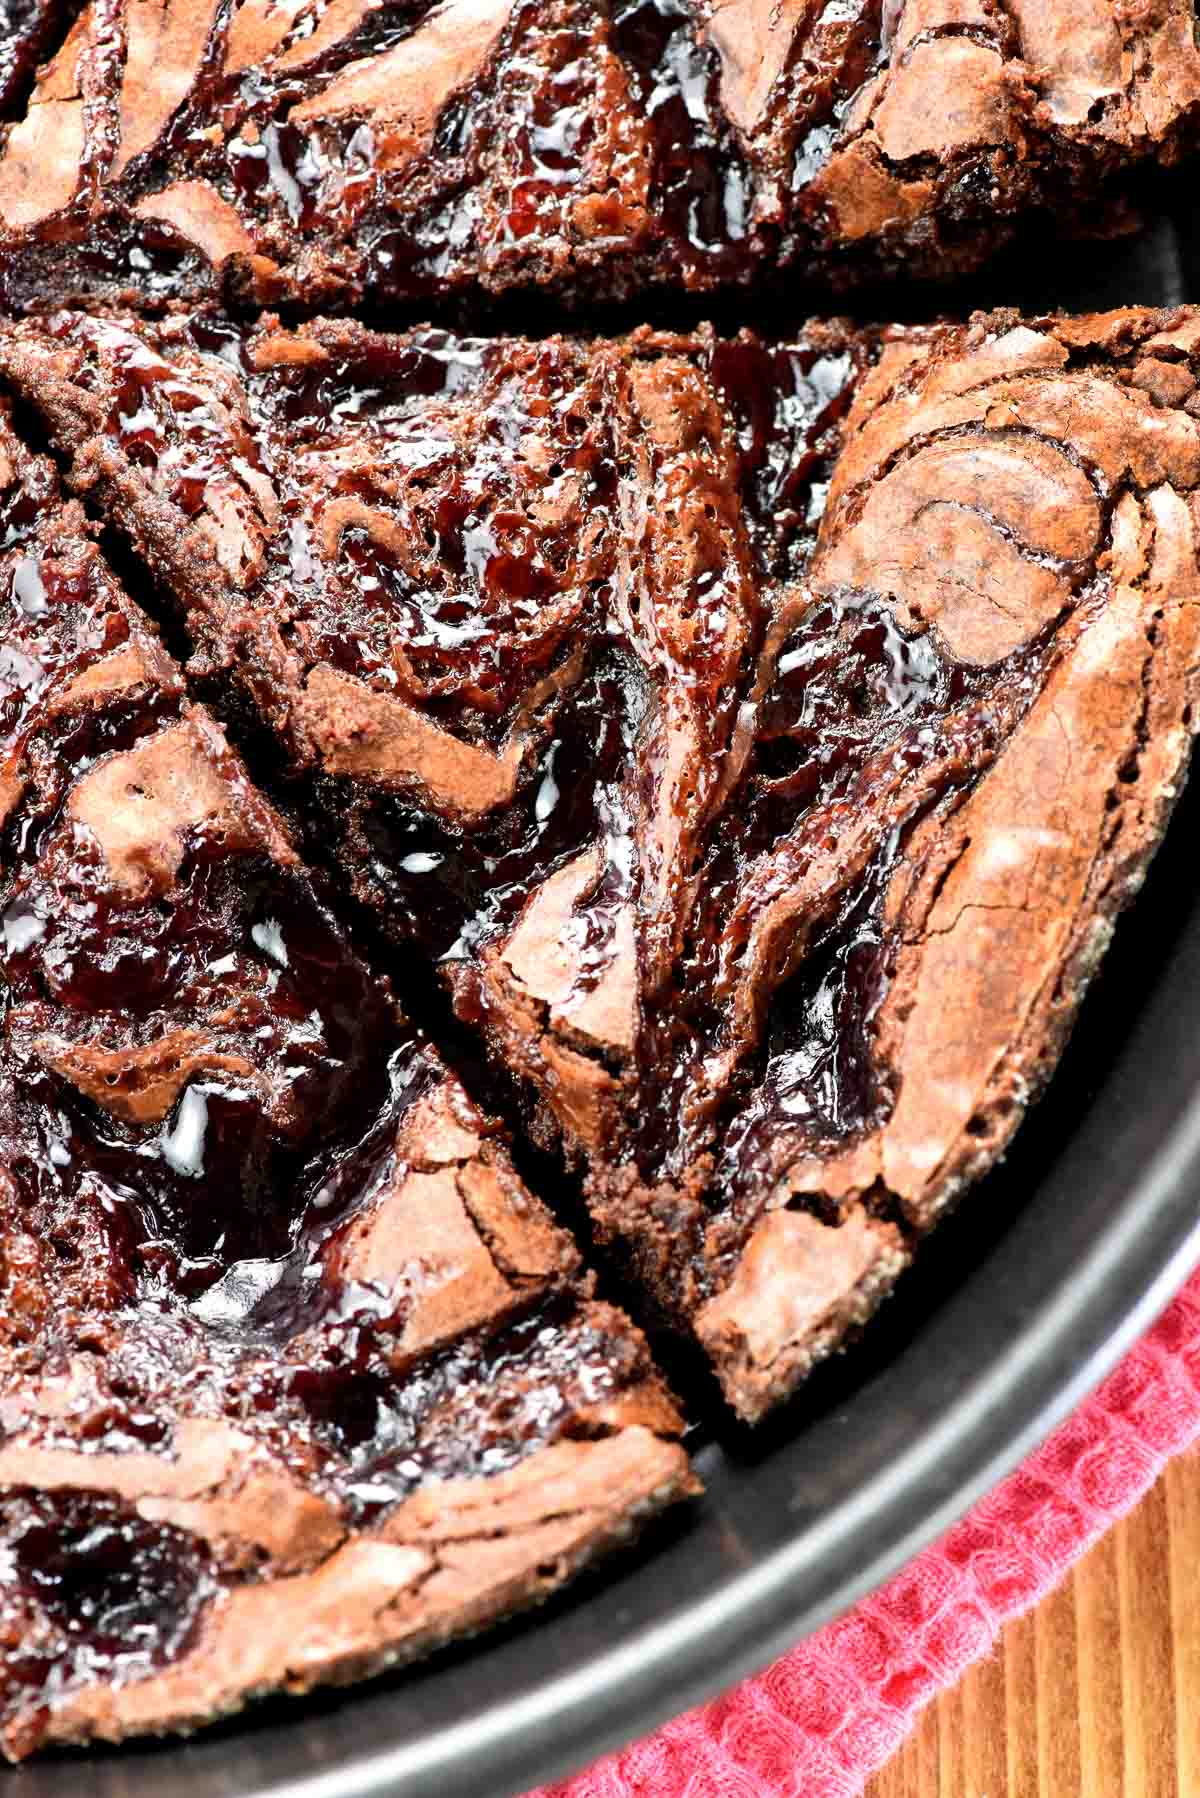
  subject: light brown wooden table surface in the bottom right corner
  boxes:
[865,1451,1200,1798]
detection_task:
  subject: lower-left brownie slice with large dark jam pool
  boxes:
[0,404,693,1758]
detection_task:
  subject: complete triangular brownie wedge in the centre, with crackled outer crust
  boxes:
[0,298,1200,1419]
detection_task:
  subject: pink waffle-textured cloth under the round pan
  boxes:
[531,1271,1200,1798]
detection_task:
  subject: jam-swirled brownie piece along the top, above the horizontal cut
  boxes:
[0,0,1200,309]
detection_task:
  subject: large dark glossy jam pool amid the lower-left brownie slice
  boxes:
[4,845,413,1298]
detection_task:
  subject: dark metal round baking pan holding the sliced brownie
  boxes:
[23,196,1200,1798]
